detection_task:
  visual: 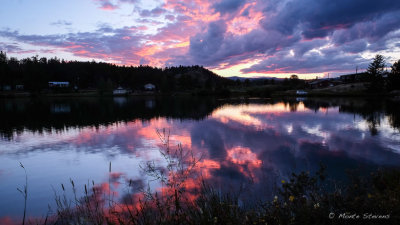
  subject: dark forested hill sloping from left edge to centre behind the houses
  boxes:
[0,52,234,92]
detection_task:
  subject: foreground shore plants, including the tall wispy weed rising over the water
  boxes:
[10,133,400,225]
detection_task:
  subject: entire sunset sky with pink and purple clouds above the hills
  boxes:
[0,0,400,78]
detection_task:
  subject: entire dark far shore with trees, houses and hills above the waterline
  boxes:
[0,52,400,98]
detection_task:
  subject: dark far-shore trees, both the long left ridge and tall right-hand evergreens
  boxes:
[0,52,400,95]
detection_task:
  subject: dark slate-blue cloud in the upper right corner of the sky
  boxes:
[261,0,400,38]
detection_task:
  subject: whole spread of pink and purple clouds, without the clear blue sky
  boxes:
[0,0,400,73]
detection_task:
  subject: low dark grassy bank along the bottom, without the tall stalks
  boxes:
[18,165,400,225]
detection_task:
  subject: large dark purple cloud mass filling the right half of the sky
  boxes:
[173,0,400,73]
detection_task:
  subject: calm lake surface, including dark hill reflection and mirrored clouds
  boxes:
[0,97,400,222]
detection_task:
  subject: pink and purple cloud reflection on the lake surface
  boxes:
[0,99,400,220]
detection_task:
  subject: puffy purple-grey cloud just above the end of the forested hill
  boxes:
[170,21,299,66]
